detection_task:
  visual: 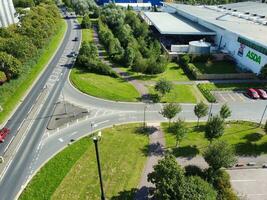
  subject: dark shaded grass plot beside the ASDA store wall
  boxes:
[193,61,237,74]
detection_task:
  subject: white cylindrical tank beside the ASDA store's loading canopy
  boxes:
[188,40,211,54]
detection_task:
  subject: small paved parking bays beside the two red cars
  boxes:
[212,91,267,103]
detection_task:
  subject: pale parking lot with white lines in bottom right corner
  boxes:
[227,169,267,200]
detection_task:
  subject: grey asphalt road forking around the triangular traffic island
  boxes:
[0,7,266,200]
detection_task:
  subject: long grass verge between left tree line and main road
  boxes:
[0,19,67,124]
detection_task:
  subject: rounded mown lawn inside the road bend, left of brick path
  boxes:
[70,68,140,102]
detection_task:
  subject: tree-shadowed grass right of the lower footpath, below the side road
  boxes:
[161,121,267,157]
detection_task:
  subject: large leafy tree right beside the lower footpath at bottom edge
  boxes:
[147,155,184,200]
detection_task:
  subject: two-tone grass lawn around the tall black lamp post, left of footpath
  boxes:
[20,124,148,200]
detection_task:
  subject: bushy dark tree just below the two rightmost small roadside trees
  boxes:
[205,115,224,142]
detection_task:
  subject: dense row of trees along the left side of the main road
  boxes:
[0,0,60,81]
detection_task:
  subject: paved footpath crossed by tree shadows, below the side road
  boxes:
[135,123,165,200]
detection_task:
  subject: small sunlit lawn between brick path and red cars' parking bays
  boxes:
[149,85,198,103]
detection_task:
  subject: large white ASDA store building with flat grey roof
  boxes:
[144,2,267,73]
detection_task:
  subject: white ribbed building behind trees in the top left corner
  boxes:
[0,0,18,27]
